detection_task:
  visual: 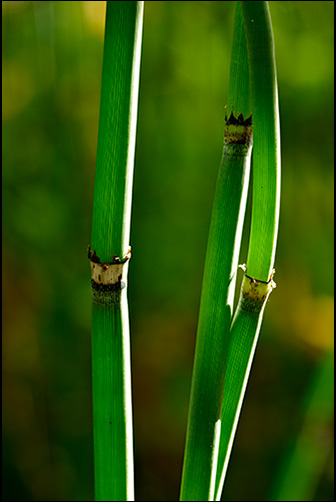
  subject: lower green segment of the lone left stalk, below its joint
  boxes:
[92,296,134,501]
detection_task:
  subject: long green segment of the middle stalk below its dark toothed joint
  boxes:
[181,143,250,500]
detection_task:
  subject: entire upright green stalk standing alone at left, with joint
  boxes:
[89,1,143,501]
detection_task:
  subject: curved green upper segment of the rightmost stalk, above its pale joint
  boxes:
[241,1,280,281]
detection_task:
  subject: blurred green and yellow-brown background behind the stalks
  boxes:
[2,1,334,501]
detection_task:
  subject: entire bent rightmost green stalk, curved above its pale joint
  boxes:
[216,1,280,500]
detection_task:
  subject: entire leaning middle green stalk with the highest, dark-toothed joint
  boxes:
[180,3,252,500]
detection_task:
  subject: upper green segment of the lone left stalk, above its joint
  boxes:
[91,1,143,262]
